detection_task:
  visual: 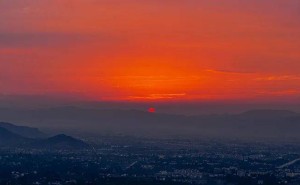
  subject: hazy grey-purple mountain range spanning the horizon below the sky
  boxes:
[0,106,300,139]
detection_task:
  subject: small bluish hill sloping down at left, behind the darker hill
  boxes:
[0,122,46,138]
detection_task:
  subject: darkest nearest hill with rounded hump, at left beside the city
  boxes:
[0,124,88,150]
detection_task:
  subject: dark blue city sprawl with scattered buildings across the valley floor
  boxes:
[0,136,300,185]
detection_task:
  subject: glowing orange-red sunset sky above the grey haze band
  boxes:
[0,0,300,102]
